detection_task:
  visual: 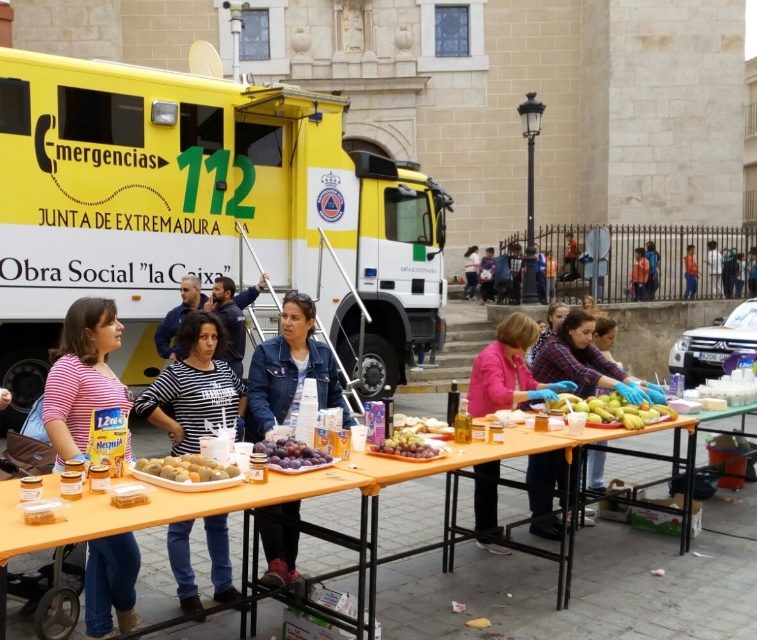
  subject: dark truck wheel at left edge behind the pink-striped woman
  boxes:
[0,347,50,432]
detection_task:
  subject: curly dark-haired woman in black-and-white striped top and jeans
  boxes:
[134,311,247,622]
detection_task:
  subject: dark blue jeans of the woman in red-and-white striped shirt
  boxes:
[84,533,141,637]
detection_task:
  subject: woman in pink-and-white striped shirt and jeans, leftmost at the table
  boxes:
[43,298,140,640]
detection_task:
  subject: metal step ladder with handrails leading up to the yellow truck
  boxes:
[236,222,371,415]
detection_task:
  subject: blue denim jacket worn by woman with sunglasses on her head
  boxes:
[246,336,356,441]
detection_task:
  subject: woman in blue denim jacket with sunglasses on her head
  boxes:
[246,291,356,587]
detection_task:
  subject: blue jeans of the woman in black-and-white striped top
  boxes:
[168,513,233,600]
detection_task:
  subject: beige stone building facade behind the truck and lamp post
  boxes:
[5,0,745,273]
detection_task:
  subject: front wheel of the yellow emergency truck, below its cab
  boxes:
[338,333,399,402]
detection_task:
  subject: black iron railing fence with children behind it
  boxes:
[499,225,757,304]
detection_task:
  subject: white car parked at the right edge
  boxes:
[668,298,757,388]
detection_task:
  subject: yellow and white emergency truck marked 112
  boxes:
[0,48,452,427]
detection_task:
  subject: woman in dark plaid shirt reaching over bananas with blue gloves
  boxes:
[526,309,665,540]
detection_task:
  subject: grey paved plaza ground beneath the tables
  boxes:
[1,394,757,640]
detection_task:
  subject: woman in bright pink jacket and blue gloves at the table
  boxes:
[468,312,576,555]
